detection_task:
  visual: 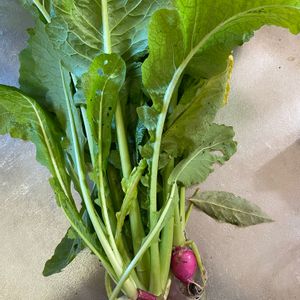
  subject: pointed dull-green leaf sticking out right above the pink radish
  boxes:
[189,191,273,227]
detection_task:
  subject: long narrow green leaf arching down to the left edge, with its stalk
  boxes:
[0,85,114,276]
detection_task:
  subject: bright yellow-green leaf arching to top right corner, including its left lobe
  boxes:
[143,0,300,110]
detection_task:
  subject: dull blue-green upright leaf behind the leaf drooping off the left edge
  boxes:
[19,19,84,161]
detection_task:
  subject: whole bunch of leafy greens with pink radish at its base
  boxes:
[0,0,300,300]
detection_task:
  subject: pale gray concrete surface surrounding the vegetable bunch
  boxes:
[0,0,300,300]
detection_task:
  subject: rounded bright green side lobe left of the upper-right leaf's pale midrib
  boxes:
[142,9,185,111]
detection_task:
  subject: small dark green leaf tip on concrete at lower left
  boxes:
[43,227,85,276]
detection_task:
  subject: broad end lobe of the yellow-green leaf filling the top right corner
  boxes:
[182,0,300,78]
